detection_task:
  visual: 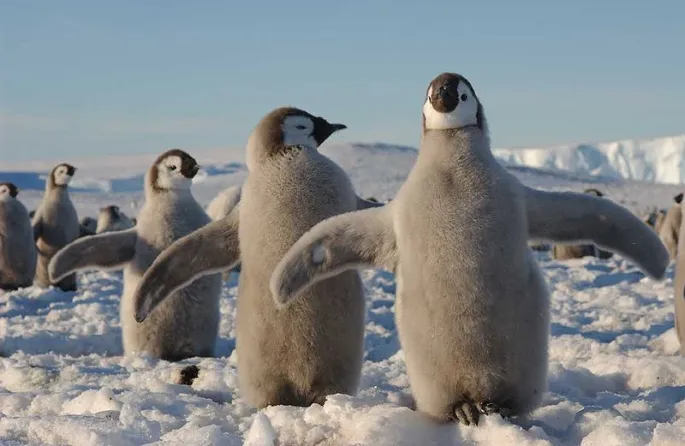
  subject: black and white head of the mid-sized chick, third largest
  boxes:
[149,149,200,191]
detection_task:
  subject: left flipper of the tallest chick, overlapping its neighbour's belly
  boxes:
[269,204,397,307]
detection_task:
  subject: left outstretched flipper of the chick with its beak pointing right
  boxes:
[133,206,240,322]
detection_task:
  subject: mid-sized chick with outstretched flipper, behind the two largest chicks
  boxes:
[50,149,221,361]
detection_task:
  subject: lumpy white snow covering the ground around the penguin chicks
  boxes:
[0,143,685,446]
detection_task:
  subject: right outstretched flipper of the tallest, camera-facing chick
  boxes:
[524,187,669,279]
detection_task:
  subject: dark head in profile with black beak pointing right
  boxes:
[247,107,347,172]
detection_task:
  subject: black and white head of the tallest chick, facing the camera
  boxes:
[423,73,484,130]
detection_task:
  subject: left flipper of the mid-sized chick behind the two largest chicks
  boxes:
[48,229,138,282]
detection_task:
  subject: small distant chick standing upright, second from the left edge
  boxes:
[32,163,81,291]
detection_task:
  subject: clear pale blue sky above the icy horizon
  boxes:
[0,0,685,162]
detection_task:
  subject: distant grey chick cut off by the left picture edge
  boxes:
[0,183,36,291]
